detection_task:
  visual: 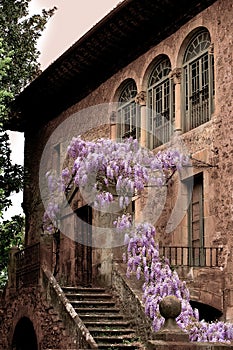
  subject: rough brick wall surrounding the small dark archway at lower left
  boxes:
[0,287,77,350]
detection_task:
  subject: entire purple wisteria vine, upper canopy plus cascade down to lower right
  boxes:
[44,137,233,342]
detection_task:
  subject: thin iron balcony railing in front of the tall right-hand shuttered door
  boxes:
[160,246,223,267]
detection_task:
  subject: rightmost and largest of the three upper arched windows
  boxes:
[183,29,214,131]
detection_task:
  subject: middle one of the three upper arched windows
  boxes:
[147,58,174,149]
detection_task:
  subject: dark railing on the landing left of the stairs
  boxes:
[15,243,40,288]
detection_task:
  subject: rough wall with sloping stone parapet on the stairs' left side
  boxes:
[0,269,97,350]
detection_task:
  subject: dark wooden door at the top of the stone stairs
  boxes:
[75,205,92,287]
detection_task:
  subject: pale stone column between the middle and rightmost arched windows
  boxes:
[169,68,182,134]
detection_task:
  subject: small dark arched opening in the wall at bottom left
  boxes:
[12,317,38,350]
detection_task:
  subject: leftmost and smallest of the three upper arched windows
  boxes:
[117,79,140,139]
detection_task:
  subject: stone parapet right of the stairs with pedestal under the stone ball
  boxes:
[113,263,233,350]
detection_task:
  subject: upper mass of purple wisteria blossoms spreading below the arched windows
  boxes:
[59,137,189,208]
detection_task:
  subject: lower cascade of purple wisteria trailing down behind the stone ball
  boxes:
[114,215,233,343]
